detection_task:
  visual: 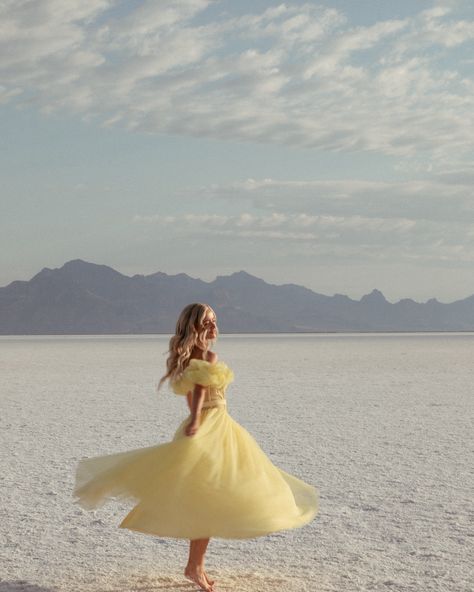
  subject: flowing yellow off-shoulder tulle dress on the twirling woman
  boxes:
[74,359,318,539]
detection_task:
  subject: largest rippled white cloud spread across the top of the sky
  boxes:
[0,0,474,162]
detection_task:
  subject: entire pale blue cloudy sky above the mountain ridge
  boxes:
[0,0,474,302]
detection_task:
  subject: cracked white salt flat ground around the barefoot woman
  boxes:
[0,334,474,592]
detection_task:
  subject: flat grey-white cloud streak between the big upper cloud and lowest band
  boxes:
[199,176,474,224]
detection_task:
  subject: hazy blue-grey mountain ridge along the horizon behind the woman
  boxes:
[0,259,474,335]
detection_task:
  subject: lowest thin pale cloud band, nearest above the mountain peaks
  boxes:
[134,212,474,267]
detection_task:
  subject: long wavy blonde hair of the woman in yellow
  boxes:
[158,302,215,389]
